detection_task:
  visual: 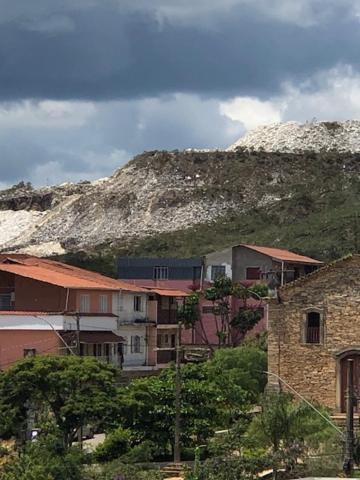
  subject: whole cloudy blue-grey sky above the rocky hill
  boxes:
[0,0,360,186]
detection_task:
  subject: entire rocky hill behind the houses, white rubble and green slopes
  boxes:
[0,122,360,272]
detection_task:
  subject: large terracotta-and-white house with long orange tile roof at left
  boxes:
[0,254,186,370]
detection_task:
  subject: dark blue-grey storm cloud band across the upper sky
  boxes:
[0,0,360,100]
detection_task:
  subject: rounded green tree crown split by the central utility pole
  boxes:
[120,365,221,454]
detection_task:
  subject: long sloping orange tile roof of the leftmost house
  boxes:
[0,254,147,293]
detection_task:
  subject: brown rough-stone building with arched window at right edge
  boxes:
[268,255,360,412]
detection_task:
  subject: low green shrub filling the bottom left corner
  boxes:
[1,433,84,480]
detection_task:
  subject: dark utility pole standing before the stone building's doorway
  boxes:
[343,359,354,477]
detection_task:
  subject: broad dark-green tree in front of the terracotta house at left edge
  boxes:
[0,356,118,447]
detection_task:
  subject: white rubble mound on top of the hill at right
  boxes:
[229,120,360,153]
